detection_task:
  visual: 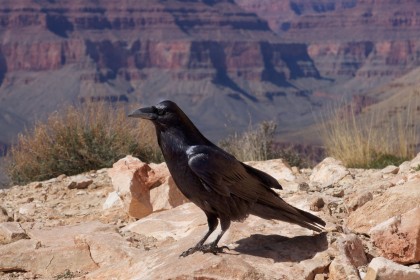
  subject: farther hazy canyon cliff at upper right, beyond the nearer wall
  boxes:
[236,0,420,88]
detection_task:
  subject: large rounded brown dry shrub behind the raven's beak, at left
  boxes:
[8,103,162,183]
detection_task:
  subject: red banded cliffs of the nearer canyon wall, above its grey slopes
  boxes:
[0,0,318,86]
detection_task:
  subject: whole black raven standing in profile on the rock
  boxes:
[129,100,325,257]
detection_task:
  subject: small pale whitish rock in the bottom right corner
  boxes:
[364,257,420,280]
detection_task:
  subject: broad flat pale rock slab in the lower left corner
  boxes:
[0,222,119,279]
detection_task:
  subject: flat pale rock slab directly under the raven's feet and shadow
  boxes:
[90,203,334,280]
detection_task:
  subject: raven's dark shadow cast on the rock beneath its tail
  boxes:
[235,233,328,262]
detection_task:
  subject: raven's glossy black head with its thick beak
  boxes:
[128,100,187,126]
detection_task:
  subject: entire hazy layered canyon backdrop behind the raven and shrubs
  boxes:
[0,0,420,149]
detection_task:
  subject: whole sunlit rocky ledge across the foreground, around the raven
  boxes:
[0,154,420,280]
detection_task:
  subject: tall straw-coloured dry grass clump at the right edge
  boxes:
[322,97,418,168]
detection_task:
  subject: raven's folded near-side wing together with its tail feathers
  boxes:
[187,145,325,232]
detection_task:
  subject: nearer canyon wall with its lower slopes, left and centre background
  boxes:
[0,0,326,144]
